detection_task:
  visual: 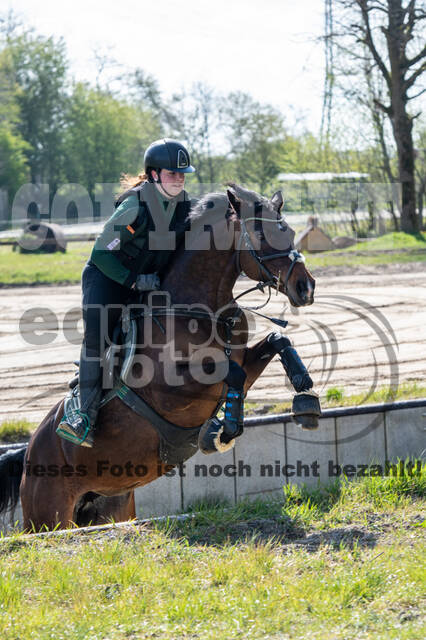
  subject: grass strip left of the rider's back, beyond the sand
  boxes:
[0,242,93,286]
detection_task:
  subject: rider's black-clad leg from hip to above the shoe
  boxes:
[79,262,130,411]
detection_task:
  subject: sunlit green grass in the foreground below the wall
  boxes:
[0,476,425,640]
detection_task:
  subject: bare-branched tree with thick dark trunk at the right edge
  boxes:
[334,0,426,232]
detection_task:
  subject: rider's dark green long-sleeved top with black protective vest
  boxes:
[90,182,191,288]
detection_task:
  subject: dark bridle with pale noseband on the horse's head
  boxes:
[236,218,305,295]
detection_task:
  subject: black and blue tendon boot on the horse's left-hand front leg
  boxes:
[223,360,247,440]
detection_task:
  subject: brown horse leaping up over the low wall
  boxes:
[0,185,315,530]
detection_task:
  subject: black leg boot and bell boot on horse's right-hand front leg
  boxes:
[268,333,321,429]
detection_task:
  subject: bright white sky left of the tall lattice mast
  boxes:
[7,0,324,133]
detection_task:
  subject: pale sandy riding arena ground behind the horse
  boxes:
[0,263,426,422]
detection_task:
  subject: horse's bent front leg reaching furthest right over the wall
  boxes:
[243,332,321,429]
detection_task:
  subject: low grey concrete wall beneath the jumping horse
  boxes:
[0,399,426,528]
